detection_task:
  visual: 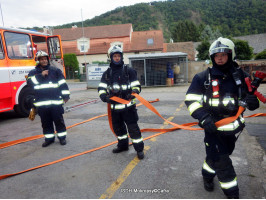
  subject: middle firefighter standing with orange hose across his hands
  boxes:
[98,46,144,159]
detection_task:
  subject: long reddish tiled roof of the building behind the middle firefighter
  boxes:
[53,24,163,55]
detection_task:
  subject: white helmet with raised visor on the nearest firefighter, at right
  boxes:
[209,37,236,60]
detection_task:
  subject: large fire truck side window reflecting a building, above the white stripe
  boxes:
[4,32,33,59]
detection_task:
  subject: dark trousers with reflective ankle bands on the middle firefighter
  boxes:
[111,106,144,152]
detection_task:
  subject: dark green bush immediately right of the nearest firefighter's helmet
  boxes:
[232,39,253,60]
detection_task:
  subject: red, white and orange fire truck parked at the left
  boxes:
[0,27,65,116]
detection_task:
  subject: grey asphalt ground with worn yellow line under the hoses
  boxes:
[0,83,266,199]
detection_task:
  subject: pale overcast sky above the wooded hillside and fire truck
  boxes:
[0,0,157,27]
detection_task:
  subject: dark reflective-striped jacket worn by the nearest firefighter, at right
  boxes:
[185,62,248,134]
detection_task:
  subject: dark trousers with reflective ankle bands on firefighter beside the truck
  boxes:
[38,105,67,141]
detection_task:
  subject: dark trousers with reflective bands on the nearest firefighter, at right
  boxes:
[202,132,239,197]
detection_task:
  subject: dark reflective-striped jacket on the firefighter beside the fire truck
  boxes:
[27,65,70,107]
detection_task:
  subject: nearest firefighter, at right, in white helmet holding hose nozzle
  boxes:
[185,37,259,198]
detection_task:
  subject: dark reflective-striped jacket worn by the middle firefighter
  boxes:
[98,64,141,110]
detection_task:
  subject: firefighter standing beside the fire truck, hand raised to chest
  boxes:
[27,51,70,147]
